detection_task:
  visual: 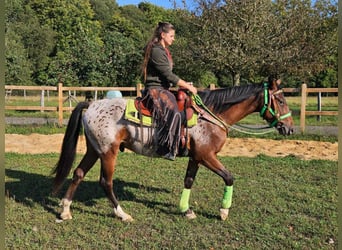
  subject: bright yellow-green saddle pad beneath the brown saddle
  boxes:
[125,99,198,127]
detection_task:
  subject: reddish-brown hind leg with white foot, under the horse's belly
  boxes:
[100,145,133,222]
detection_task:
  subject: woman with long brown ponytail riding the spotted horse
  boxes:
[143,22,197,160]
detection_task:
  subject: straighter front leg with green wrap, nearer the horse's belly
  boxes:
[179,158,198,219]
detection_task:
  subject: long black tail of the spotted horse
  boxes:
[52,102,89,194]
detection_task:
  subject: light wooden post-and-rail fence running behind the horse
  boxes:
[5,83,338,133]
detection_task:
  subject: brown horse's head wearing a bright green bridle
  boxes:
[260,77,293,135]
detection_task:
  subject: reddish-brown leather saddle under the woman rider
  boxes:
[134,88,194,155]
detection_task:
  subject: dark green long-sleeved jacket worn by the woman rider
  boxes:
[145,44,179,89]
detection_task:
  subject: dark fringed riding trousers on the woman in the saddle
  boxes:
[146,88,181,155]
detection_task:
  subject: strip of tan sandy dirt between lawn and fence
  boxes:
[5,134,338,161]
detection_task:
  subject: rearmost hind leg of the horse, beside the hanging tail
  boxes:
[60,143,99,220]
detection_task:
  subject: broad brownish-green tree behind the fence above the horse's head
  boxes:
[189,0,337,85]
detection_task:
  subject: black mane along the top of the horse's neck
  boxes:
[198,84,263,113]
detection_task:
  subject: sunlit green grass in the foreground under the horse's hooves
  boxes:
[5,153,338,249]
